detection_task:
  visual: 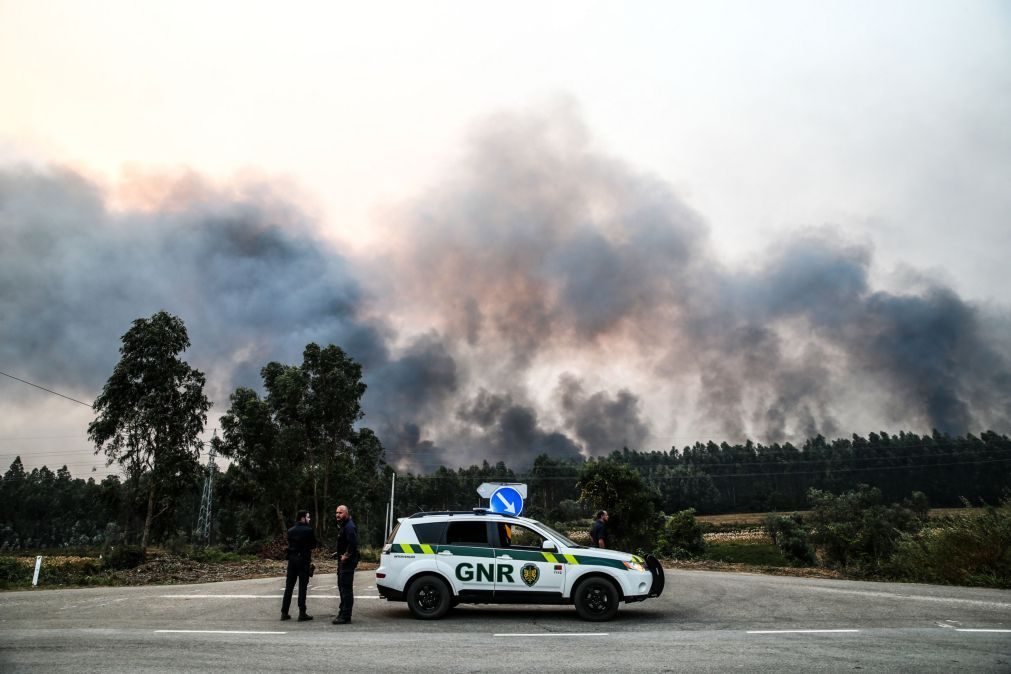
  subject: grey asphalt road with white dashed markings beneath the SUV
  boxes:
[0,571,1011,673]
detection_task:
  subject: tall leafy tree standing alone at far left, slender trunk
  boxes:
[88,311,210,551]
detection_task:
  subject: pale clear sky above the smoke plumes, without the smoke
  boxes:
[0,0,1011,468]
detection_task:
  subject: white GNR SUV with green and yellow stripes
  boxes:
[376,509,664,620]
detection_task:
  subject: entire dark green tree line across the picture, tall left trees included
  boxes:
[0,311,1011,552]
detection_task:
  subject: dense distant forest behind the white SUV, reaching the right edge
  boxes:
[397,430,1011,521]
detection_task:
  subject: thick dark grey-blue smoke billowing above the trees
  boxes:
[0,109,1011,470]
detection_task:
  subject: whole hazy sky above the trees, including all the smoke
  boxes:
[0,0,1011,474]
